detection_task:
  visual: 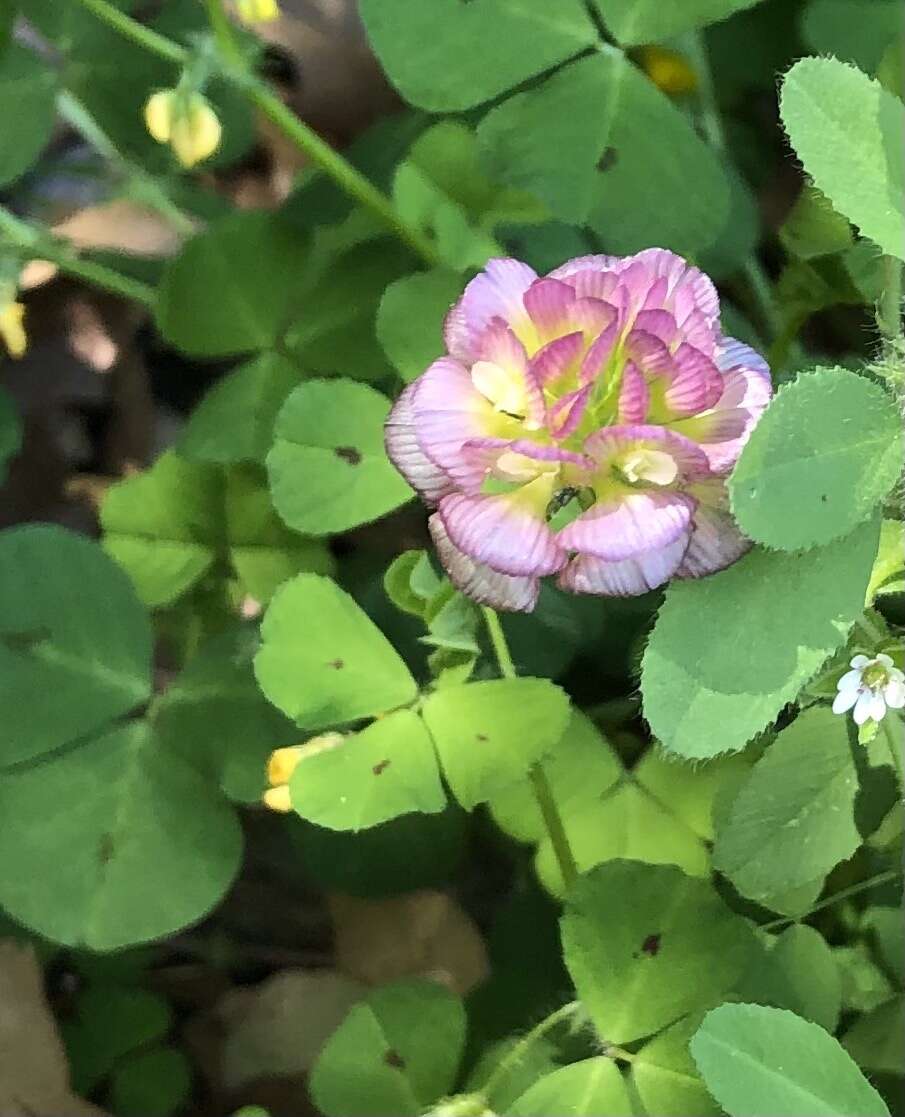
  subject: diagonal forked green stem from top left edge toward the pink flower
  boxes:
[71,0,441,267]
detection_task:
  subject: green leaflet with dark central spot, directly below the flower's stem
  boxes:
[561,861,754,1044]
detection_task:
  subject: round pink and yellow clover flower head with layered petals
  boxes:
[385,248,772,611]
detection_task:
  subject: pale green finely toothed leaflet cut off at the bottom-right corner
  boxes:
[692,1004,889,1117]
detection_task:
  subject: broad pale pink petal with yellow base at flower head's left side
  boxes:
[409,357,505,493]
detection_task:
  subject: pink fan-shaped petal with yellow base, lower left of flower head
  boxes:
[438,478,566,577]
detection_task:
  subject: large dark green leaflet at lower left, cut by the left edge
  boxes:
[0,722,242,951]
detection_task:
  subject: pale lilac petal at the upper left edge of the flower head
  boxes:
[444,259,537,364]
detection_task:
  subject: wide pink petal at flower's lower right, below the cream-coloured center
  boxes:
[554,489,697,561]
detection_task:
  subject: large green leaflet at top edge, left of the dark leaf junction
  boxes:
[361,0,597,113]
